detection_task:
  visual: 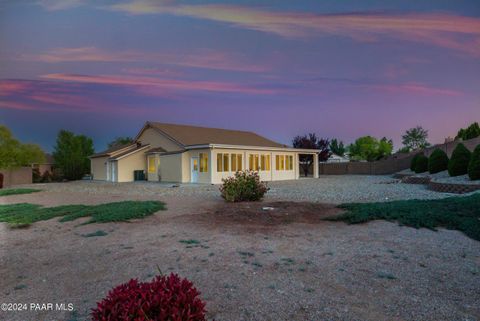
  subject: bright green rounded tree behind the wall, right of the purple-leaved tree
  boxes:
[348,136,393,162]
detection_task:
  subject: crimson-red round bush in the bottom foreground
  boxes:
[92,273,206,321]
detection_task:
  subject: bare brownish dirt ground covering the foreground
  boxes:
[0,191,480,320]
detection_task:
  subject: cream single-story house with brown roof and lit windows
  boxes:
[90,122,318,184]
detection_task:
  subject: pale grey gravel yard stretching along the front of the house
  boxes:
[17,175,452,204]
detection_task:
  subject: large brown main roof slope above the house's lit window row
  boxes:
[140,122,286,147]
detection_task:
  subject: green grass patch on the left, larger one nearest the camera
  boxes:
[0,201,166,227]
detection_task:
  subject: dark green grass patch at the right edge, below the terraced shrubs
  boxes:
[327,193,480,241]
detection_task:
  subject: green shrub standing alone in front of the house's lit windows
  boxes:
[220,171,268,202]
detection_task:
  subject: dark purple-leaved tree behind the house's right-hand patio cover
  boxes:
[292,133,331,176]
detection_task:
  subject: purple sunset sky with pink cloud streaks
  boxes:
[0,0,480,151]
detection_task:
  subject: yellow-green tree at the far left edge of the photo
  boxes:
[0,125,45,169]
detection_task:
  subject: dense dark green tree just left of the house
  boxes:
[53,130,94,180]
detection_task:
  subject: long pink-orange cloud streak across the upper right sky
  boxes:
[108,0,480,57]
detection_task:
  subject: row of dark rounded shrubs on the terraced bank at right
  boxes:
[410,143,480,180]
